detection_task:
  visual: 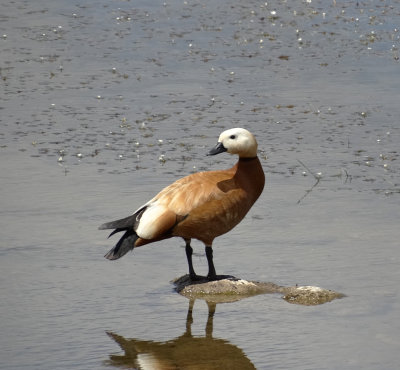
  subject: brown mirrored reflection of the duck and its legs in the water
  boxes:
[107,300,255,370]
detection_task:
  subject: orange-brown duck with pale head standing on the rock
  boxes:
[99,128,265,281]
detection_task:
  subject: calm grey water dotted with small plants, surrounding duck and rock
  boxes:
[0,0,400,369]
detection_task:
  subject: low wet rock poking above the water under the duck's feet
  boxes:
[172,275,344,306]
